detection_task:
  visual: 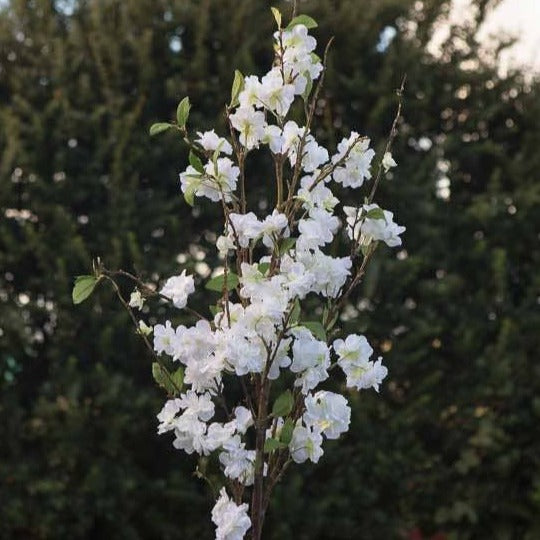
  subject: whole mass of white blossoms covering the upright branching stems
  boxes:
[141,12,405,540]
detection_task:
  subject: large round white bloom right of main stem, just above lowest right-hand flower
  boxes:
[303,391,351,439]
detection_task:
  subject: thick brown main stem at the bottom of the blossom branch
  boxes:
[251,376,268,540]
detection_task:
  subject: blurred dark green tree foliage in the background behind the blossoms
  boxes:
[0,0,540,540]
